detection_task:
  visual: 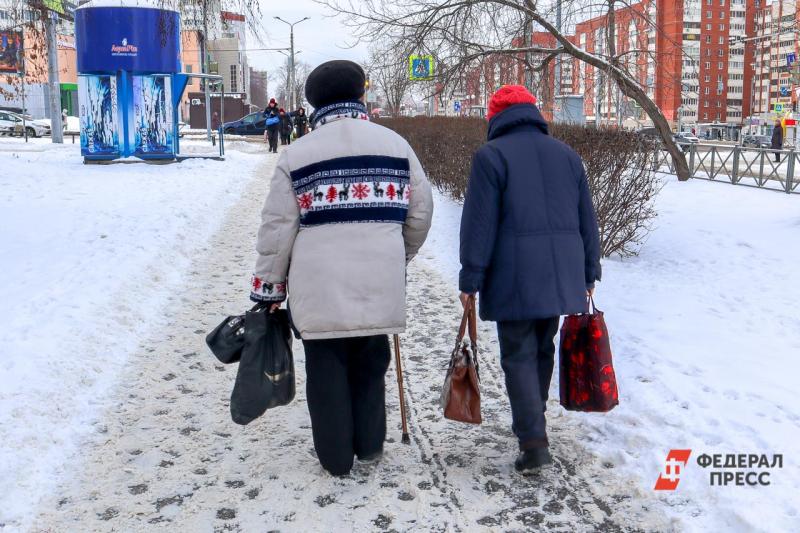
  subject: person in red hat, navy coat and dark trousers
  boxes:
[459,85,601,471]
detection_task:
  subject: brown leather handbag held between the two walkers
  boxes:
[440,297,481,424]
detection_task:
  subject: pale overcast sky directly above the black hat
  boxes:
[247,0,367,80]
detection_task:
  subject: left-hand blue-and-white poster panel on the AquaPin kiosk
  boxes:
[78,75,120,156]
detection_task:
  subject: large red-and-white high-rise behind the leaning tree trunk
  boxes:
[573,0,755,128]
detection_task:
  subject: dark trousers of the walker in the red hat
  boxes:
[497,316,558,450]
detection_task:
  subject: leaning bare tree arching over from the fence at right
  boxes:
[318,0,690,180]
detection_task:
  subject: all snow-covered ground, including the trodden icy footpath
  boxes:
[0,131,800,531]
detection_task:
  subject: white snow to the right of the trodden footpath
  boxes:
[422,177,800,531]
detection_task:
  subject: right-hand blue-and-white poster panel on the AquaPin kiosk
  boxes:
[133,75,175,157]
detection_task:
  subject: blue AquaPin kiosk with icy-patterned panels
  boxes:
[75,0,216,162]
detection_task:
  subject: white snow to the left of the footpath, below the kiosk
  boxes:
[0,139,259,529]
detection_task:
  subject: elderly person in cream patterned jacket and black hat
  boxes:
[251,61,433,475]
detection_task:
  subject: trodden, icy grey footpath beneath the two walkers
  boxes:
[26,152,671,532]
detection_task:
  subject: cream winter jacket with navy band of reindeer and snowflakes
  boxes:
[251,110,433,339]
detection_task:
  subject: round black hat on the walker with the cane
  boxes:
[306,59,367,109]
